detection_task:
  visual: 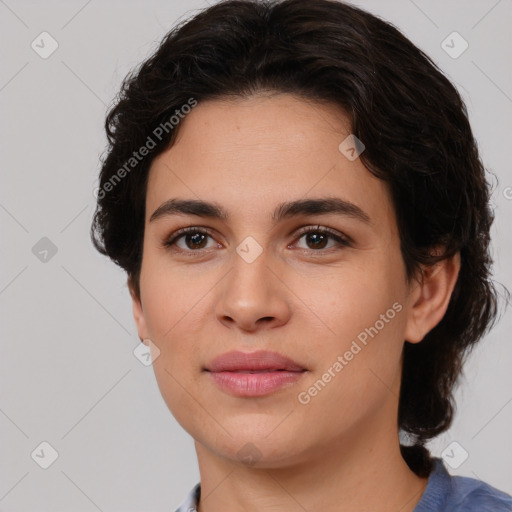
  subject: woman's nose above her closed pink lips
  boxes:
[215,251,291,332]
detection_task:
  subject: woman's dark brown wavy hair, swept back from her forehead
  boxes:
[91,0,506,476]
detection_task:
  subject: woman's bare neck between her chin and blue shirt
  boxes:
[195,407,428,512]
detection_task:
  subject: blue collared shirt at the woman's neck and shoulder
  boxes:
[175,458,512,512]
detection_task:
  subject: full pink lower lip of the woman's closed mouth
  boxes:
[208,371,306,397]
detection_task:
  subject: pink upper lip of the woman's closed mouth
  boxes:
[205,350,306,373]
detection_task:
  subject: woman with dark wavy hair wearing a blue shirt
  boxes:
[92,0,512,512]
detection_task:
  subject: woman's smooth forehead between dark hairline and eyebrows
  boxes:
[146,94,394,233]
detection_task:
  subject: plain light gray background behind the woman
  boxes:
[0,0,512,512]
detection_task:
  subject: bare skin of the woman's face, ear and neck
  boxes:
[129,93,460,512]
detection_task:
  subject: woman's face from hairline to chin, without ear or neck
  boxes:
[134,94,420,467]
